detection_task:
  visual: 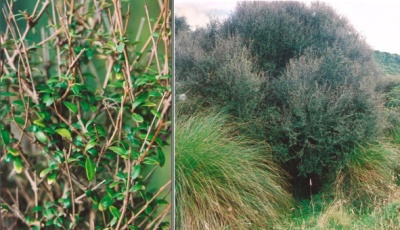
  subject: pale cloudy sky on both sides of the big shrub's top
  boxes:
[174,0,400,54]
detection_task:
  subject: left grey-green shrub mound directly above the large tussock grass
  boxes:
[175,25,263,118]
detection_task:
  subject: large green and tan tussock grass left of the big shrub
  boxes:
[175,106,292,230]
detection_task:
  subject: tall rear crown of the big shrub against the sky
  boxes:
[221,1,372,76]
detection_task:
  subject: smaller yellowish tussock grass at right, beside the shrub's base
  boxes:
[334,142,400,209]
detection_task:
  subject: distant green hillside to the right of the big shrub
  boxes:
[374,50,400,75]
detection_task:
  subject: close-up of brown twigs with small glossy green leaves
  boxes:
[0,0,171,229]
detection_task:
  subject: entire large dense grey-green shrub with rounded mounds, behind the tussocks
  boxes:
[176,2,384,190]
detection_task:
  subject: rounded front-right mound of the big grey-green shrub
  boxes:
[265,49,383,176]
